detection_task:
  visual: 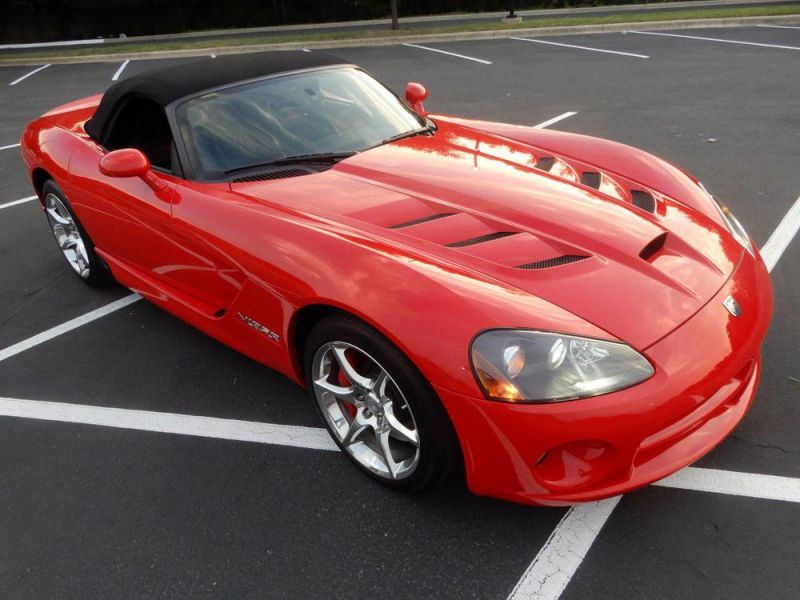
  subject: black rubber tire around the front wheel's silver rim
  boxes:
[303,314,463,492]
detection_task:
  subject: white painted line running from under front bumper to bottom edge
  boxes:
[508,496,621,600]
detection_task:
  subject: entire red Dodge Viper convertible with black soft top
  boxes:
[22,52,772,505]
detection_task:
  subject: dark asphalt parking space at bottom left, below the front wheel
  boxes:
[0,420,560,598]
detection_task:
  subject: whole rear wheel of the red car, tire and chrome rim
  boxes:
[42,179,108,286]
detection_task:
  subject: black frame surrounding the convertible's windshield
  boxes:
[164,63,428,183]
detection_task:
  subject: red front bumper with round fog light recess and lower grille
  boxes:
[436,254,772,505]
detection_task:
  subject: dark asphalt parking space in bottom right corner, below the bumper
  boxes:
[562,488,800,600]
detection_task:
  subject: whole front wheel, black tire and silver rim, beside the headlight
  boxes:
[305,316,460,491]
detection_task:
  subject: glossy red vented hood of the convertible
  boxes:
[231,122,742,349]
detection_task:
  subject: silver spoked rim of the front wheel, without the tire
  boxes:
[312,341,420,480]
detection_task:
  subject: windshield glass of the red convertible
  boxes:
[175,67,424,179]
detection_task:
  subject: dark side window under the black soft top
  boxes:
[104,98,174,171]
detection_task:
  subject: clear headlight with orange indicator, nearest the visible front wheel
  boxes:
[471,329,654,402]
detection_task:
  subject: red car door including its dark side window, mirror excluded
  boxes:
[71,98,245,314]
